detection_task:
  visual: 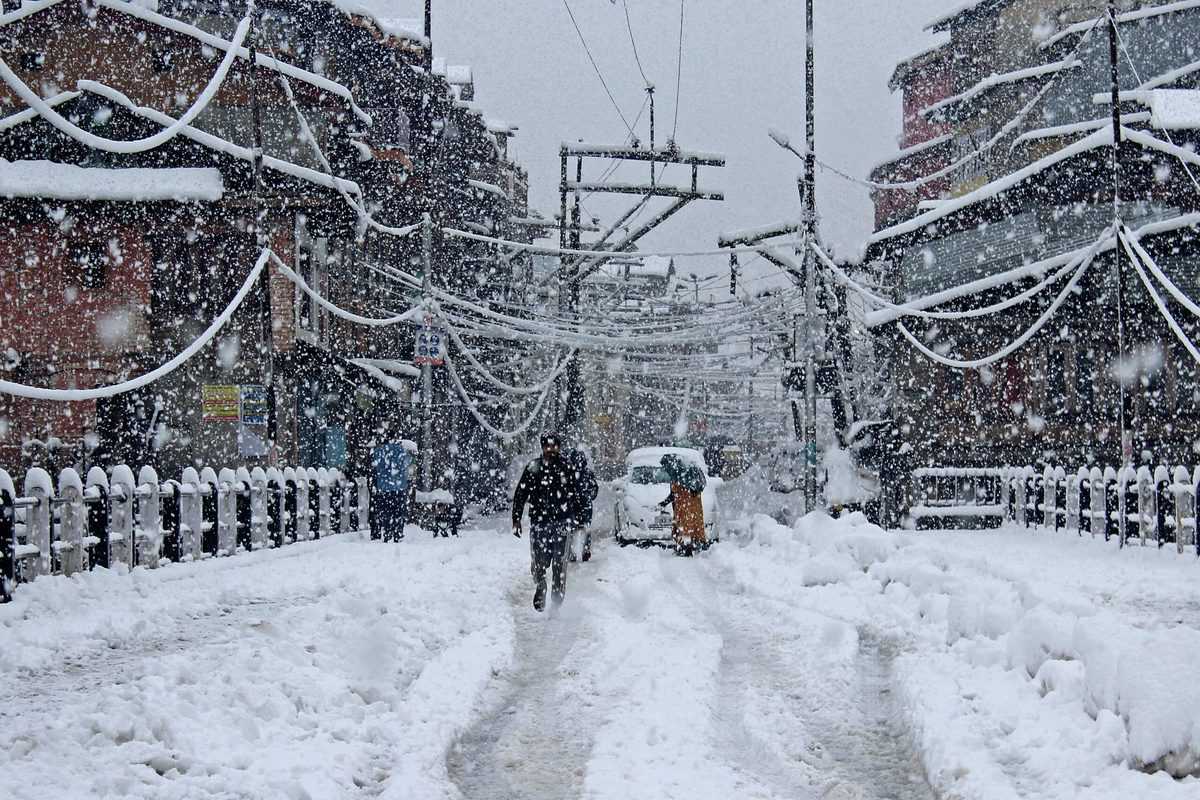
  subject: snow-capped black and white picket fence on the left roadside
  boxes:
[0,464,371,602]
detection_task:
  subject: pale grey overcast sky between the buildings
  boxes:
[364,0,962,286]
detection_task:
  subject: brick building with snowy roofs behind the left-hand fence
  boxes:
[0,0,528,489]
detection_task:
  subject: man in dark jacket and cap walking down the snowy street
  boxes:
[512,434,576,610]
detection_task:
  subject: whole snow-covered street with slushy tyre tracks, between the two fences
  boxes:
[0,517,1200,800]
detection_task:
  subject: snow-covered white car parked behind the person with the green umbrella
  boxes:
[613,447,722,545]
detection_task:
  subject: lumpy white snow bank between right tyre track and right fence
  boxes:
[720,515,1200,800]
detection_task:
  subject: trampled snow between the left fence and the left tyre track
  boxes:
[0,534,527,800]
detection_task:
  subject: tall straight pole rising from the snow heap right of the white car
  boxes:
[800,0,817,511]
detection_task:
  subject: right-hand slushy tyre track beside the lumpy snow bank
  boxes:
[698,545,936,800]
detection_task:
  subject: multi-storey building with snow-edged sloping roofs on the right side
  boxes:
[868,0,1200,464]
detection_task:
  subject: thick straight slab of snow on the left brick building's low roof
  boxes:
[0,158,224,203]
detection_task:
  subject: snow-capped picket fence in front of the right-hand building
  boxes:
[908,465,1200,557]
